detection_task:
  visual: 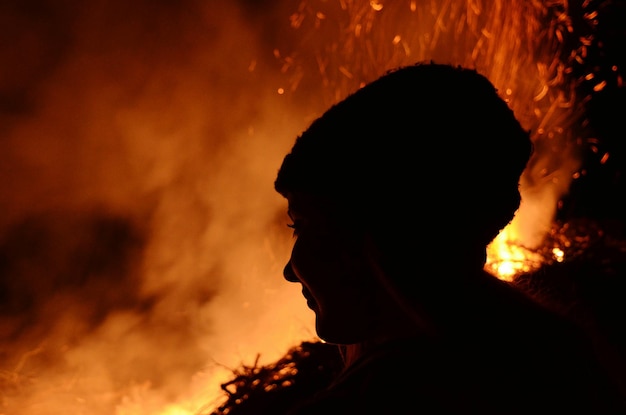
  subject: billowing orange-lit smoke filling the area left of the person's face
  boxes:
[0,0,312,415]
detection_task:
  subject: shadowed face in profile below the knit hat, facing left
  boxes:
[284,194,377,344]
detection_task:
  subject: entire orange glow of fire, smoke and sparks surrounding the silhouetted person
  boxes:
[0,0,604,415]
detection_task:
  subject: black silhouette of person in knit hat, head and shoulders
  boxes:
[275,62,625,415]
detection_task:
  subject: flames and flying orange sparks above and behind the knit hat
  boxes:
[278,0,584,281]
